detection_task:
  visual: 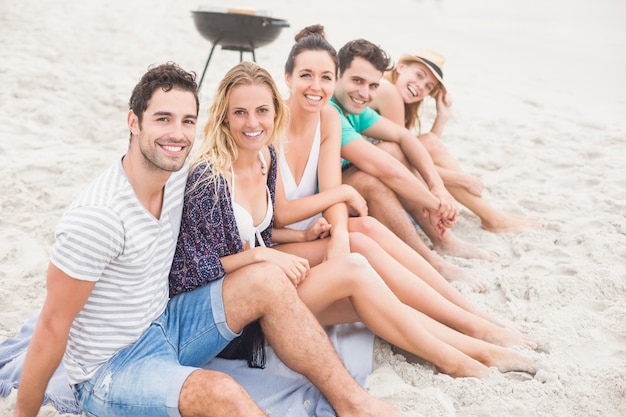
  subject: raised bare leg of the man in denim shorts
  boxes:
[223,262,403,417]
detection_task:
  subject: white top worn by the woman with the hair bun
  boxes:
[278,121,322,230]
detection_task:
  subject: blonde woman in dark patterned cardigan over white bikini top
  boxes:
[170,62,534,377]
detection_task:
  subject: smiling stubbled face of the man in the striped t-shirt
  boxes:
[128,88,197,173]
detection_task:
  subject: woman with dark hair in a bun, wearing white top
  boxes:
[272,27,536,368]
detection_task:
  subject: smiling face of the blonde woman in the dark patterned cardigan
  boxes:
[225,84,276,151]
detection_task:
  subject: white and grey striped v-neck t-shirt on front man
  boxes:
[51,160,188,384]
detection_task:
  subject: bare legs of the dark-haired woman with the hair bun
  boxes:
[275,232,536,349]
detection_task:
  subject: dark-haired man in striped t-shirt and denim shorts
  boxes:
[14,63,400,417]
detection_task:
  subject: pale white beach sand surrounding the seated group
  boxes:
[0,0,626,417]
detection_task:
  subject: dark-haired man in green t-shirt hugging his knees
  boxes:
[331,39,488,286]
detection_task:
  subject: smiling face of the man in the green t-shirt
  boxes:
[334,57,383,114]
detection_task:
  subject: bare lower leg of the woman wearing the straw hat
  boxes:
[418,133,537,233]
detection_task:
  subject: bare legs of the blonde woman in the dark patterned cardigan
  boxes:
[298,254,533,378]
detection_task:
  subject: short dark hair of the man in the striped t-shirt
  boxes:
[128,62,195,123]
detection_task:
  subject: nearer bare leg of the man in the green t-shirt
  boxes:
[343,167,485,291]
